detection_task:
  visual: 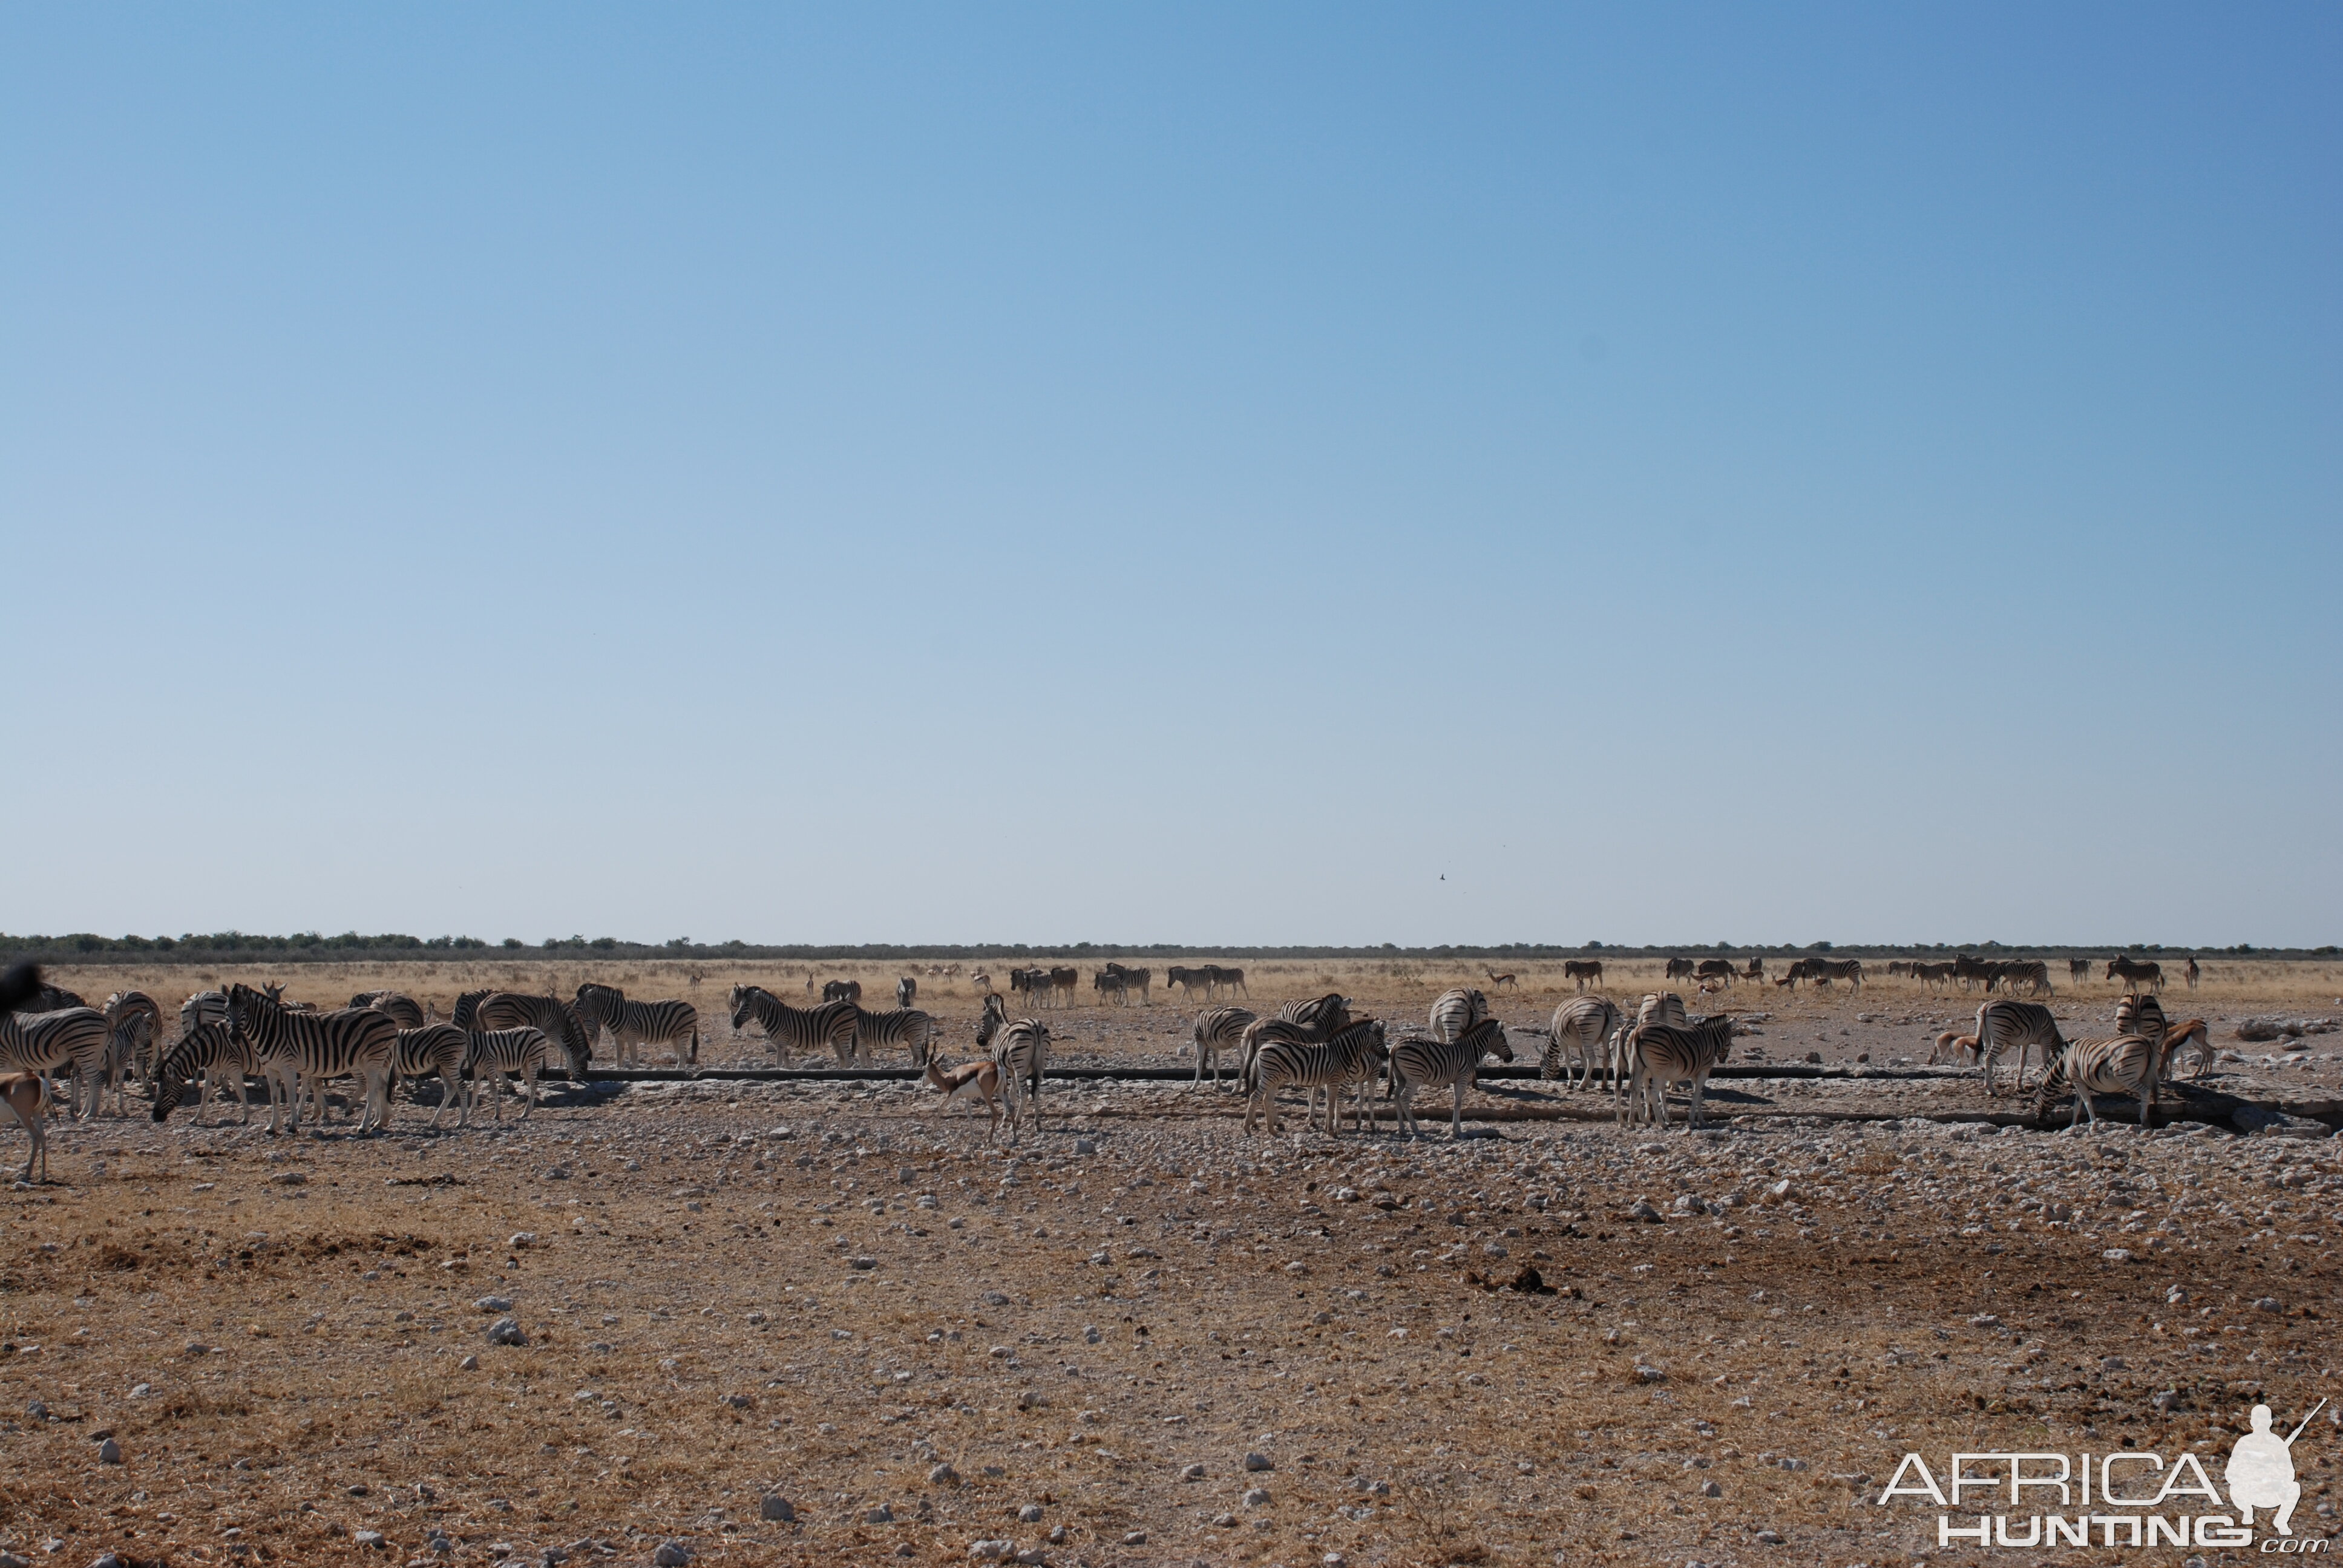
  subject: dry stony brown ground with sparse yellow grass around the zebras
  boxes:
[0,963,2343,1568]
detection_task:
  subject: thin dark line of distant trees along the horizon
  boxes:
[0,930,2343,963]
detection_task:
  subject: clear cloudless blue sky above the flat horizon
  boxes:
[0,5,2343,944]
